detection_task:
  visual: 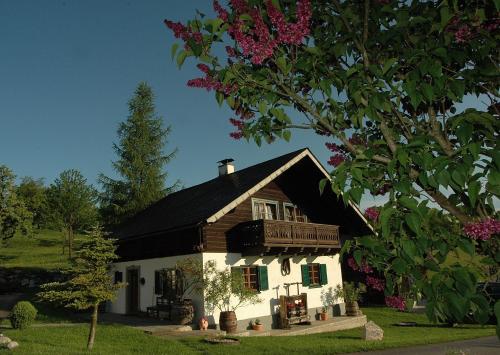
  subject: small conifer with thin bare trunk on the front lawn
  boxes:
[38,227,125,350]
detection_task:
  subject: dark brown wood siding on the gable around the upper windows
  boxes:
[203,181,291,252]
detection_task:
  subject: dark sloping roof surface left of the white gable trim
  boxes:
[116,149,306,239]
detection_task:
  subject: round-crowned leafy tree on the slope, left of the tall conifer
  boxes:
[48,169,97,258]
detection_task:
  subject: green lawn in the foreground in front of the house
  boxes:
[4,308,495,355]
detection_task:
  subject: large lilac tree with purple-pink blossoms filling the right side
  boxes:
[165,0,500,330]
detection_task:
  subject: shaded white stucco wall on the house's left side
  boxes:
[108,253,203,314]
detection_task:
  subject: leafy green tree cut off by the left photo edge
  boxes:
[0,165,33,242]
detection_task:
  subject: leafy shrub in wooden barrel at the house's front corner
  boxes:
[203,260,262,333]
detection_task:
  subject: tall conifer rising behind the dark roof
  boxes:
[99,82,178,226]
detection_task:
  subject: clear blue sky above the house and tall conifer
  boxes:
[0,0,336,196]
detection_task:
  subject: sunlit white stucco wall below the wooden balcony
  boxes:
[203,253,342,323]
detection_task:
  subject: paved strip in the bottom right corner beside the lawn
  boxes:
[352,336,500,355]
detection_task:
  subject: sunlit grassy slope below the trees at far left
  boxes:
[0,230,84,271]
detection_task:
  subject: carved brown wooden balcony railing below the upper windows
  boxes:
[238,219,340,252]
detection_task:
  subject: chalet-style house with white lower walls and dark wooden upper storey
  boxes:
[109,149,367,328]
